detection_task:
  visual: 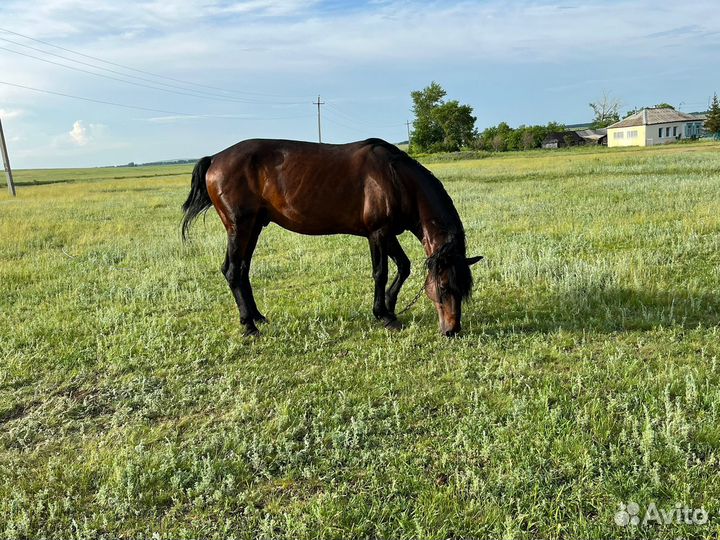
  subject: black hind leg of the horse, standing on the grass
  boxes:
[223,214,265,336]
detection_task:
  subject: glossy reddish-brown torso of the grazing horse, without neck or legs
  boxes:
[207,139,414,236]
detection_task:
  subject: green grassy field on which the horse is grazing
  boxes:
[0,144,720,540]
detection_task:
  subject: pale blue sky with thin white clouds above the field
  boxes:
[0,0,720,168]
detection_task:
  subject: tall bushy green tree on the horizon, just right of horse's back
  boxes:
[410,81,477,152]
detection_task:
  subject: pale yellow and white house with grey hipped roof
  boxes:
[607,109,704,146]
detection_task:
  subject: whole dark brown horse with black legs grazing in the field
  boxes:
[183,139,481,336]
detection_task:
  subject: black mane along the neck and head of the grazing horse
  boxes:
[363,139,473,300]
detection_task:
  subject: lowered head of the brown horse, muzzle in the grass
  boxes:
[425,244,482,337]
